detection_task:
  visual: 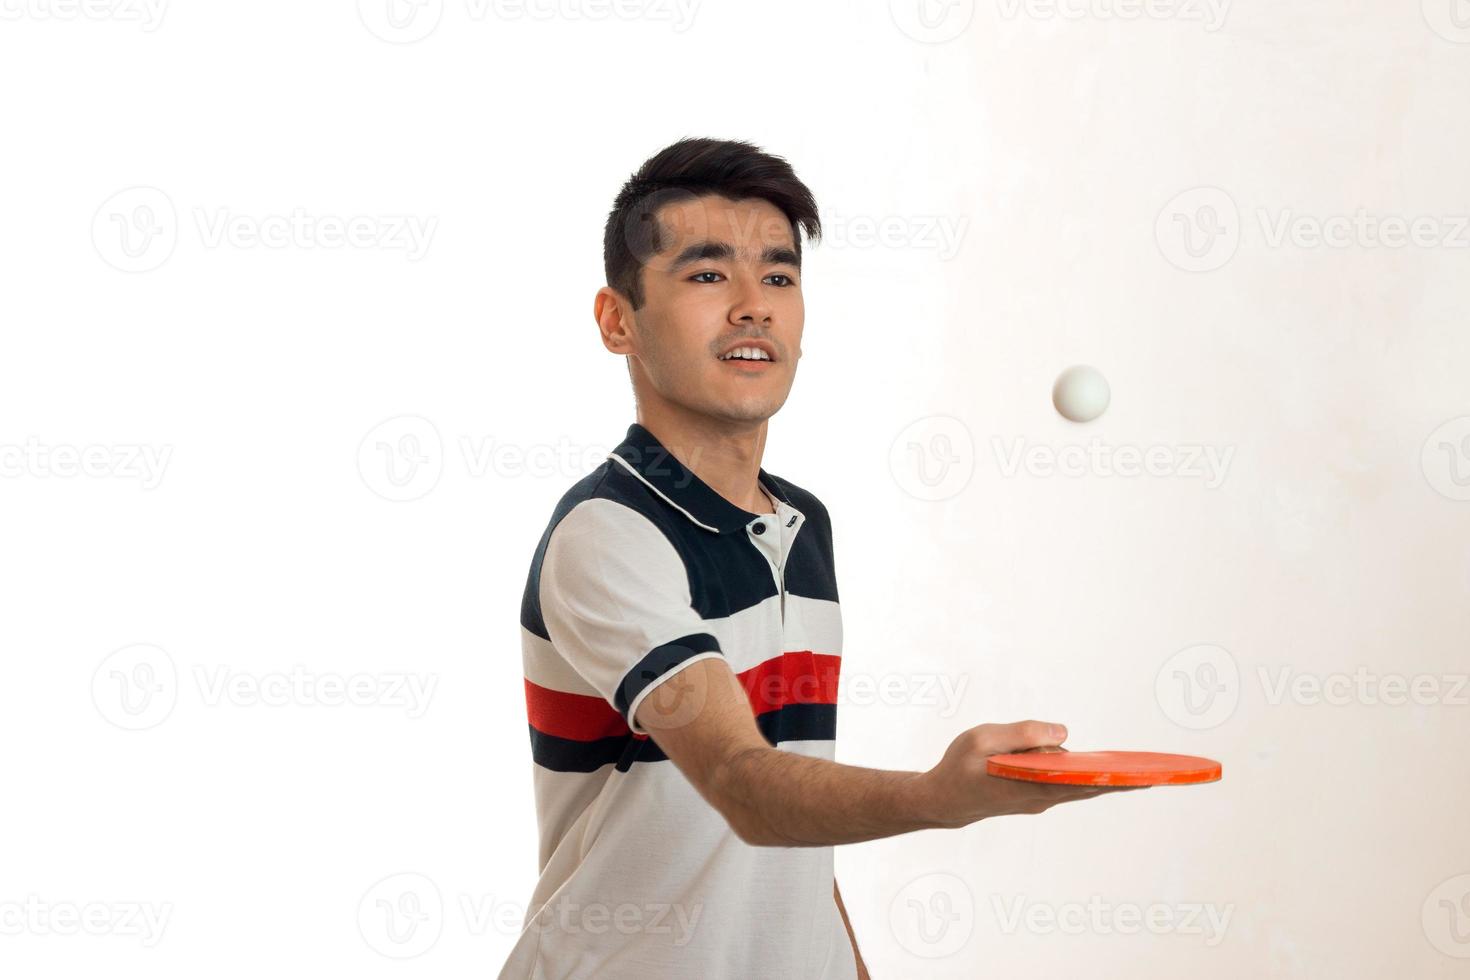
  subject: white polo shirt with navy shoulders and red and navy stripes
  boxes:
[500,423,857,980]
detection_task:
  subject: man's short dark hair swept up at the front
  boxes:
[603,138,822,310]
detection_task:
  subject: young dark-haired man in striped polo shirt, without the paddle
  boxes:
[500,140,1128,980]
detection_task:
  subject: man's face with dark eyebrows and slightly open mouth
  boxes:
[625,195,806,422]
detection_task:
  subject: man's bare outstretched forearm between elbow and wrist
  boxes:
[719,746,948,848]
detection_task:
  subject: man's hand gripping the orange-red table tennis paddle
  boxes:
[919,721,1142,827]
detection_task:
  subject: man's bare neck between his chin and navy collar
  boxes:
[638,406,772,514]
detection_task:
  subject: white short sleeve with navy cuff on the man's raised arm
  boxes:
[539,498,723,735]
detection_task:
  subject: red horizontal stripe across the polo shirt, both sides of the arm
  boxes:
[525,649,842,742]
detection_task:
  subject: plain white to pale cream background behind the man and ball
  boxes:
[0,0,1470,979]
